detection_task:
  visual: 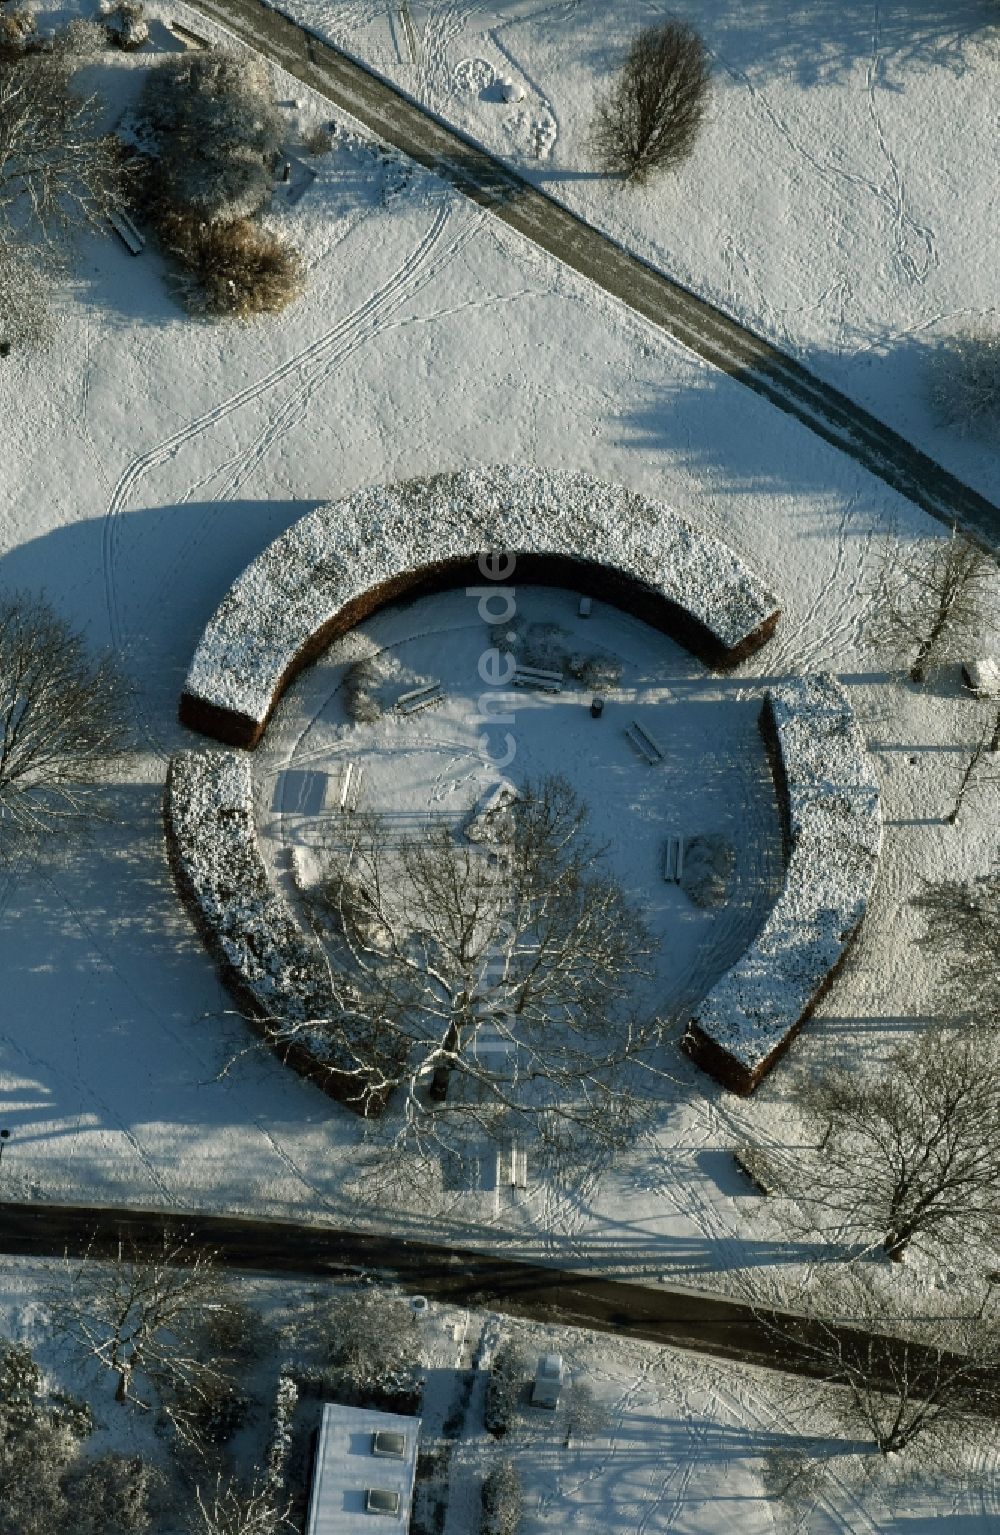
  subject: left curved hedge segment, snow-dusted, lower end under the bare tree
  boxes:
[163,751,386,1114]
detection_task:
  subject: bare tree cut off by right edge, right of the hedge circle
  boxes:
[912,869,1000,1024]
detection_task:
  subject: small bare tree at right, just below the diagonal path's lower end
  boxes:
[869,528,997,683]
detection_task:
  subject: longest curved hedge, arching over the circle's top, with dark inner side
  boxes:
[180,467,779,748]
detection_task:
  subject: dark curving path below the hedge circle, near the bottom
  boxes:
[0,1203,983,1394]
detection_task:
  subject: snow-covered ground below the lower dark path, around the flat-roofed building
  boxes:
[0,1259,997,1535]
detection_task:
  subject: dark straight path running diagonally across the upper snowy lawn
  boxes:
[189,0,1000,545]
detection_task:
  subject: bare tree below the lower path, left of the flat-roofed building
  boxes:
[58,1230,236,1418]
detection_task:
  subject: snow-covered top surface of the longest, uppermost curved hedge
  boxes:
[186,467,777,721]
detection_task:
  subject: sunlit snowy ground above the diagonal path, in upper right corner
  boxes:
[272,0,1000,499]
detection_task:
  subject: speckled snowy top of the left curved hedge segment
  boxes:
[166,751,333,1047]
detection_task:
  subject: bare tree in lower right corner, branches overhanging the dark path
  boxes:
[750,1263,1000,1455]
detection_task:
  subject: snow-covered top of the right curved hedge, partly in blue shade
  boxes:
[696,674,882,1071]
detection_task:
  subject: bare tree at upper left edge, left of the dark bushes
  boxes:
[0,54,121,241]
